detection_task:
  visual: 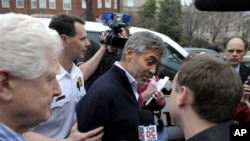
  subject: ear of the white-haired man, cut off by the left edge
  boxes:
[0,68,12,101]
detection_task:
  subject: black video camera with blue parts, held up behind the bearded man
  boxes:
[101,13,131,48]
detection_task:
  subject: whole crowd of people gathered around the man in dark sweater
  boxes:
[0,13,250,141]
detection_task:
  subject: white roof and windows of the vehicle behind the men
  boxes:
[38,18,189,80]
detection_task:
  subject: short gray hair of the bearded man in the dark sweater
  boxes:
[122,31,167,60]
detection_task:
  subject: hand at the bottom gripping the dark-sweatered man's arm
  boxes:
[66,124,103,141]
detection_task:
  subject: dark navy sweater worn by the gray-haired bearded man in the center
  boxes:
[76,65,140,141]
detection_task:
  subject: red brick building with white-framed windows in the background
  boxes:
[0,0,121,18]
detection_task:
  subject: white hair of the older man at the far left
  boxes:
[0,13,62,80]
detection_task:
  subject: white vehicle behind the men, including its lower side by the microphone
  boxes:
[38,18,186,140]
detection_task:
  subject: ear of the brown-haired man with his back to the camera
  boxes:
[177,86,191,107]
